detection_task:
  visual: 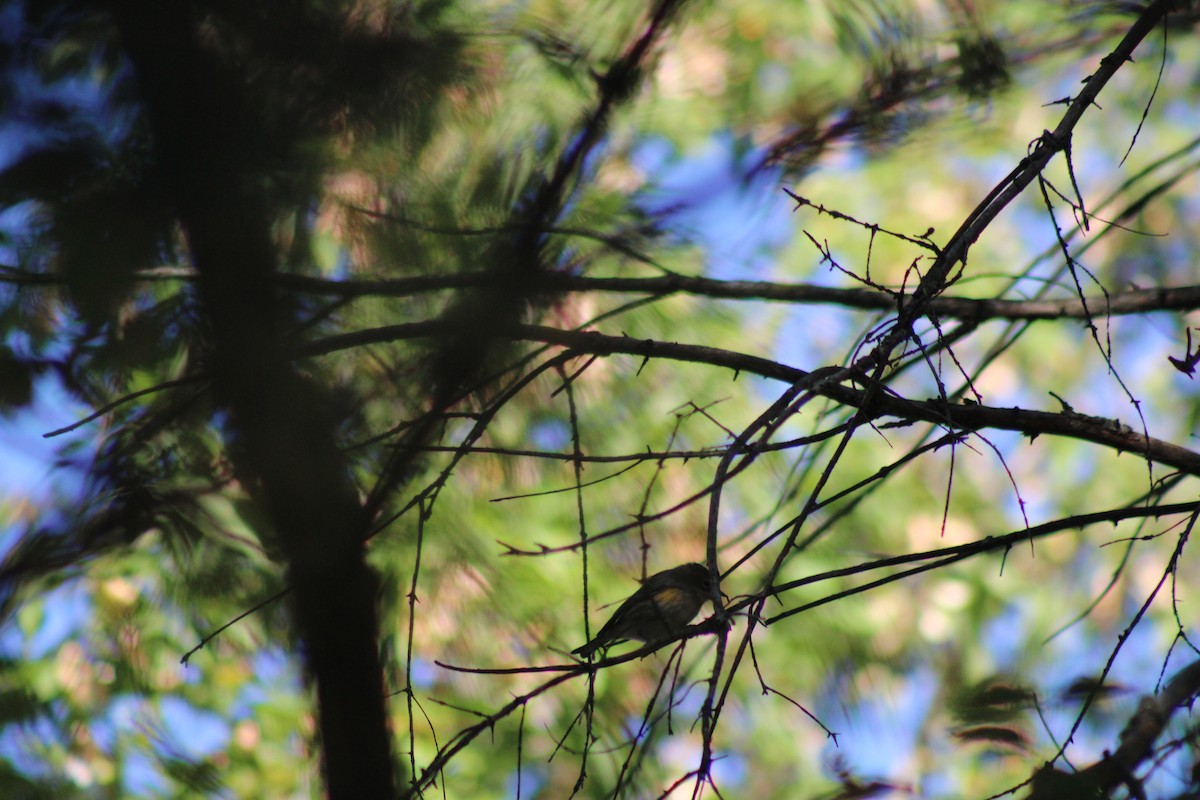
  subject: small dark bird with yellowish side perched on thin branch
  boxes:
[571,564,712,658]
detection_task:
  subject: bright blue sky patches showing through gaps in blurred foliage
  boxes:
[0,6,1200,794]
